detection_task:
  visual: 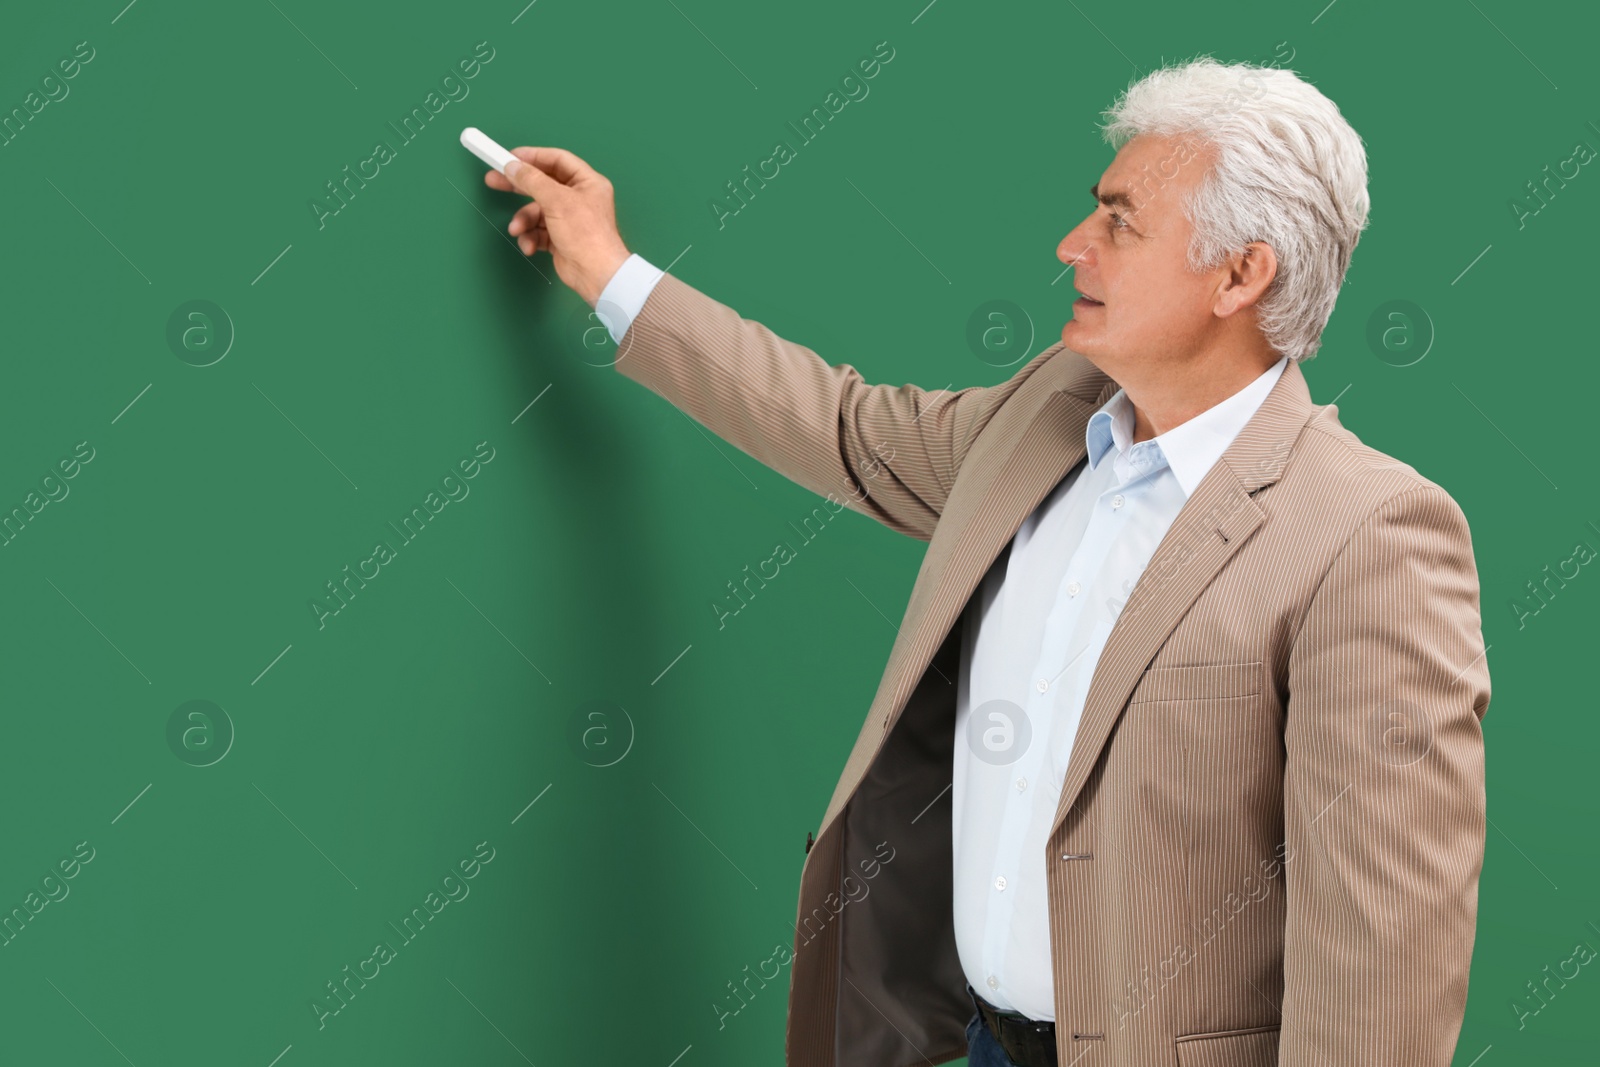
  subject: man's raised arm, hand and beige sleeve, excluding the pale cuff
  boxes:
[485,147,1059,541]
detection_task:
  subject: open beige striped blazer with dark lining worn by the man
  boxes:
[616,274,1490,1067]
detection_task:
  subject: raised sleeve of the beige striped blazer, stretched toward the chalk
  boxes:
[614,274,1061,541]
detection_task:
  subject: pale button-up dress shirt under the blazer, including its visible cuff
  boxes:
[595,254,1288,1021]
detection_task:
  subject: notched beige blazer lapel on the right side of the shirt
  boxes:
[1051,360,1317,833]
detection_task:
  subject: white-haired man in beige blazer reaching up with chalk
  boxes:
[485,58,1490,1067]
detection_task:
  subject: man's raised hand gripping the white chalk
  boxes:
[483,147,629,307]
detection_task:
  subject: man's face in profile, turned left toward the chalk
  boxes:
[1056,134,1227,379]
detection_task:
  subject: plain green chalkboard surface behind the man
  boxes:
[0,0,1600,1067]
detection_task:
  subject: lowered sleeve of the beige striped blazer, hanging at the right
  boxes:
[1278,483,1490,1067]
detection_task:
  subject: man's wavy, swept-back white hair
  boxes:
[1102,56,1368,360]
